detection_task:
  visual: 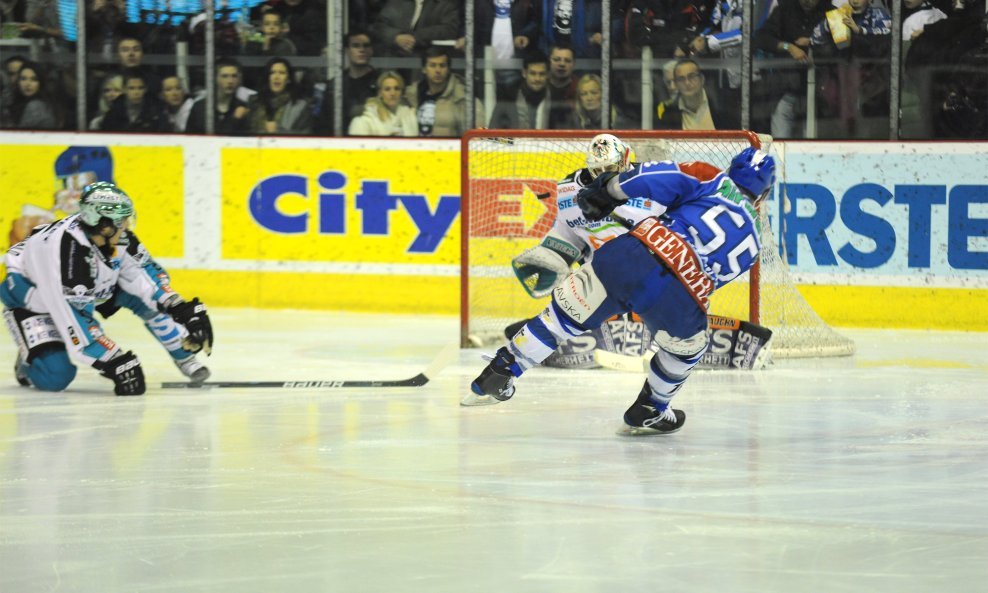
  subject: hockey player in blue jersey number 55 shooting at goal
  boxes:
[461,148,775,434]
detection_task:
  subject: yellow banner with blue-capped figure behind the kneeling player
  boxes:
[0,144,185,258]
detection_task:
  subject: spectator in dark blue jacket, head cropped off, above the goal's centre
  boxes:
[542,0,604,60]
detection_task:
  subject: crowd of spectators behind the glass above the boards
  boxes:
[0,0,988,139]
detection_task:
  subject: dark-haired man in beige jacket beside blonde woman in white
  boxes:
[405,47,483,138]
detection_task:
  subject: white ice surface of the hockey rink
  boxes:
[0,309,988,593]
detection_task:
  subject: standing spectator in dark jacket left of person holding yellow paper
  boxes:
[754,0,834,138]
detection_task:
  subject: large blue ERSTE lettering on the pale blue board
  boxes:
[773,183,988,271]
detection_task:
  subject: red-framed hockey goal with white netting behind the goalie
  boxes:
[460,130,854,358]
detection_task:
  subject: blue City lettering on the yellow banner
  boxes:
[249,171,460,253]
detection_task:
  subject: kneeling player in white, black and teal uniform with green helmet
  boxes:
[0,182,213,395]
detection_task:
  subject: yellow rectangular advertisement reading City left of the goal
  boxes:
[220,147,460,264]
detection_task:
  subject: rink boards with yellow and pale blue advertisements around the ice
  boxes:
[0,132,988,330]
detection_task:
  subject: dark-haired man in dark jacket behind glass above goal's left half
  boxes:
[488,51,550,130]
